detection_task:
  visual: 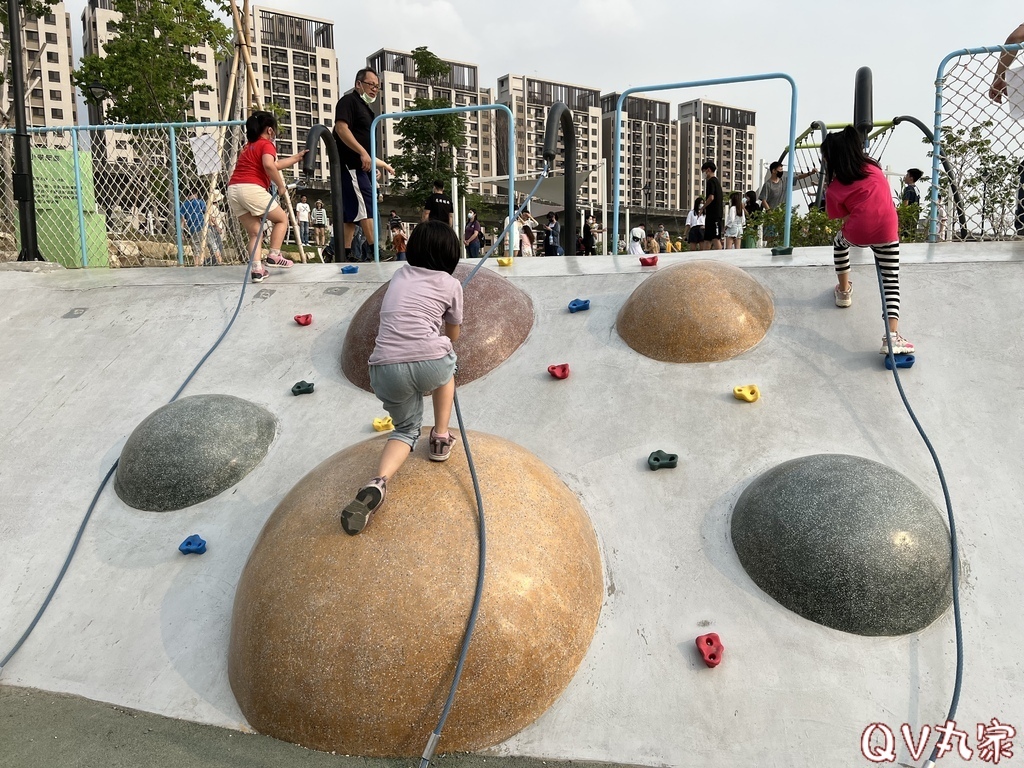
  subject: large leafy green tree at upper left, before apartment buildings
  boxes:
[72,0,231,123]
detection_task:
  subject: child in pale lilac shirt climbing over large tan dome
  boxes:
[341,220,463,536]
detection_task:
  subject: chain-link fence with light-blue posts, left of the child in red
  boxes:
[0,122,272,267]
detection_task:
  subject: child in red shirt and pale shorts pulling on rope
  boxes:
[227,112,306,283]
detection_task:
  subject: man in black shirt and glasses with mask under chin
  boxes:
[334,67,394,261]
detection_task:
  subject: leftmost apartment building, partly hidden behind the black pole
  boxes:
[0,2,78,134]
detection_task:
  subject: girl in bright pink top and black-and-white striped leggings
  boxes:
[821,125,913,354]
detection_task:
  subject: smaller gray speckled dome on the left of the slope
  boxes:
[114,394,278,512]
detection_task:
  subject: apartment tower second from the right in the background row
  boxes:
[601,93,679,210]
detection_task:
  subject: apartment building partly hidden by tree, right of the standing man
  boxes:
[368,49,498,195]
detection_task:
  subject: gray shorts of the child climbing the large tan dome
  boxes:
[370,352,457,451]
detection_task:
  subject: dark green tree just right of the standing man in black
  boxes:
[391,46,469,205]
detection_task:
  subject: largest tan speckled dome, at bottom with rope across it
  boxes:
[228,432,603,758]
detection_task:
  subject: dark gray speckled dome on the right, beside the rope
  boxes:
[732,454,952,636]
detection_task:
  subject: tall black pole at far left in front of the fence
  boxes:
[7,0,43,261]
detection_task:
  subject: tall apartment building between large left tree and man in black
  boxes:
[239,6,341,183]
